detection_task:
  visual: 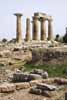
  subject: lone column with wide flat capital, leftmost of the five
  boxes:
[14,13,22,43]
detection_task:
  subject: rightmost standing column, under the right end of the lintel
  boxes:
[48,17,53,40]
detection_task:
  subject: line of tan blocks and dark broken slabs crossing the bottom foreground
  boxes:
[0,78,67,97]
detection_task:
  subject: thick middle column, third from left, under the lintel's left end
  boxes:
[32,16,39,40]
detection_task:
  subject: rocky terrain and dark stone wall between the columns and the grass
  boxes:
[0,42,67,69]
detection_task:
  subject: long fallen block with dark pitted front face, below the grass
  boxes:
[12,72,41,82]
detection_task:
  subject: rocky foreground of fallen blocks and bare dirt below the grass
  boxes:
[0,70,67,100]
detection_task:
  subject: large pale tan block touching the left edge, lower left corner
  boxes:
[0,83,15,93]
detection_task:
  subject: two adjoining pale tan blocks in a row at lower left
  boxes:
[0,82,30,93]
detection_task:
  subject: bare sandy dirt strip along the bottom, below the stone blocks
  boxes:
[0,81,67,100]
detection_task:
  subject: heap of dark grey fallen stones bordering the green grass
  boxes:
[12,69,48,82]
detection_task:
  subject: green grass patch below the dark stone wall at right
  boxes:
[25,64,67,78]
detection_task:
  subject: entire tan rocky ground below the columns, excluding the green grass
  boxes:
[0,43,67,100]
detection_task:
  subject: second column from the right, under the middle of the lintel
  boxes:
[40,17,46,40]
